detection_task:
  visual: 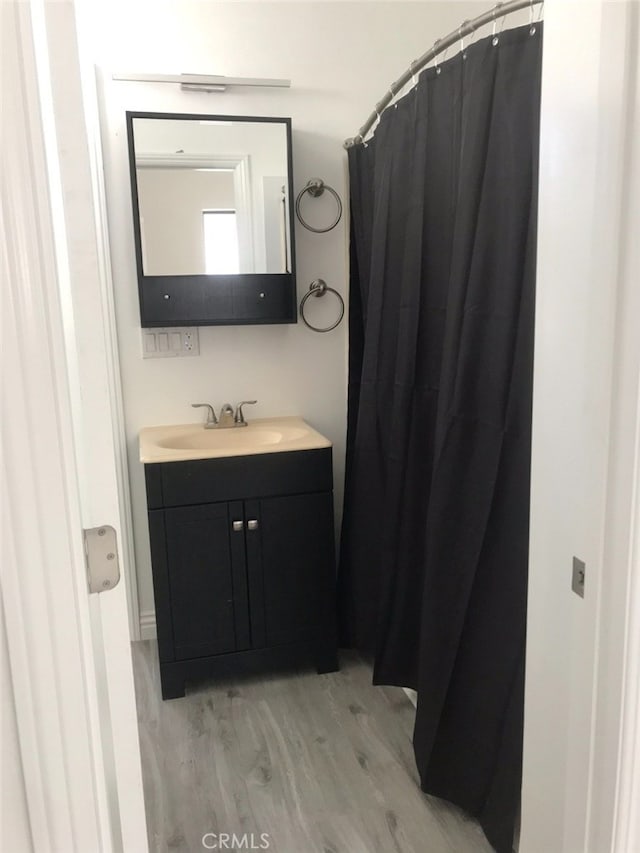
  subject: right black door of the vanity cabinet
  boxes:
[245,493,335,647]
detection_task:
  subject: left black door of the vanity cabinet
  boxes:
[165,503,249,660]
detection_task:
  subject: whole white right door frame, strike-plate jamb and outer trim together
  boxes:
[520,0,640,853]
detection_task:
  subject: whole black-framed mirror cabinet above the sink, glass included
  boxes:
[127,112,297,327]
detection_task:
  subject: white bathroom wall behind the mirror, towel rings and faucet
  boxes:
[90,2,480,622]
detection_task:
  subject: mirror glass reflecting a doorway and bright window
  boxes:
[132,115,292,276]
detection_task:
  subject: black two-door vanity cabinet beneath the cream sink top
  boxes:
[145,448,337,699]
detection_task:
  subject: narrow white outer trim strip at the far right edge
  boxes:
[587,10,640,853]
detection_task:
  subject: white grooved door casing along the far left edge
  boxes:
[2,3,118,851]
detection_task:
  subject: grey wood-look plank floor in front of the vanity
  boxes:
[133,642,491,853]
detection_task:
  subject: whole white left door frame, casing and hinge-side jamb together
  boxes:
[0,0,148,853]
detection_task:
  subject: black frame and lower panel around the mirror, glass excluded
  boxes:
[126,110,298,328]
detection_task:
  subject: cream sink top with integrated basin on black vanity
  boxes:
[140,417,331,464]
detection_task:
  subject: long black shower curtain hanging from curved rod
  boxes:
[339,25,542,853]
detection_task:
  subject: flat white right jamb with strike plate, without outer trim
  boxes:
[520,0,637,853]
